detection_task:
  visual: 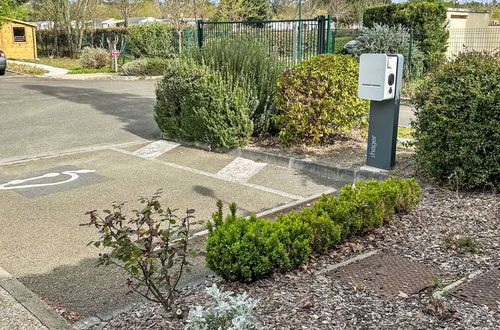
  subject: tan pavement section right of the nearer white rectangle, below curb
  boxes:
[248,164,347,197]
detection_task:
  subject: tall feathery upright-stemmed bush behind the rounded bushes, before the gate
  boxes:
[191,38,285,135]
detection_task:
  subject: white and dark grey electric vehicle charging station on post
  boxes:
[358,54,404,170]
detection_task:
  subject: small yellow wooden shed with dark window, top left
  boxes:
[0,19,37,59]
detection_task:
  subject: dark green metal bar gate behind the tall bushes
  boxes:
[197,16,331,64]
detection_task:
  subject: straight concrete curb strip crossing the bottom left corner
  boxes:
[0,267,72,330]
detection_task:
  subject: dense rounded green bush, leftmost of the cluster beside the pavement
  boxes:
[154,59,253,148]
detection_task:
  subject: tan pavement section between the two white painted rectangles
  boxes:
[157,146,236,174]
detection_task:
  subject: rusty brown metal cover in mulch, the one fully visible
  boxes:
[331,254,439,298]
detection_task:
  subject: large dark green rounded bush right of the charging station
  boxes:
[414,52,500,189]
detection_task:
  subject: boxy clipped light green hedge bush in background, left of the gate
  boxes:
[126,22,173,58]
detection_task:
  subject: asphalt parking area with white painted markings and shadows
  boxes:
[0,76,340,318]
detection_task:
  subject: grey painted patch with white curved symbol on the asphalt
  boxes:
[0,165,110,198]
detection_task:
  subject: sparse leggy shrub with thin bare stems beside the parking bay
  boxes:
[82,190,194,310]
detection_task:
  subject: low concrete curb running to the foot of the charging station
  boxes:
[229,147,390,182]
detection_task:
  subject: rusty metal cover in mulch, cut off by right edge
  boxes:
[450,269,500,311]
